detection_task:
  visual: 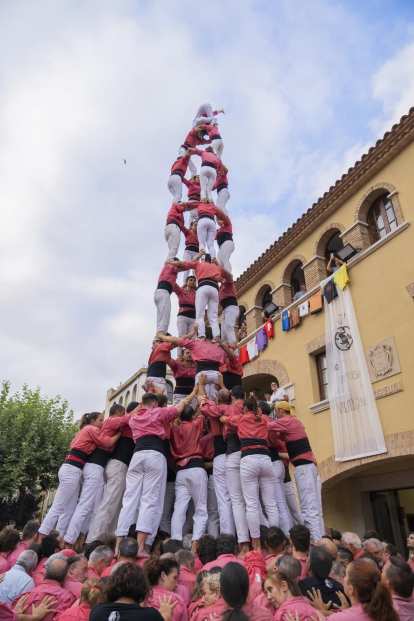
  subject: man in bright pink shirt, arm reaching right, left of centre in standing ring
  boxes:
[115,393,192,556]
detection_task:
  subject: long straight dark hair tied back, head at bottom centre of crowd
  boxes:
[220,563,250,621]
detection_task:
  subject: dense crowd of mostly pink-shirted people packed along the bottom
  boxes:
[0,522,414,621]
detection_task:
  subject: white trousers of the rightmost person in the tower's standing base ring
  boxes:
[295,464,325,543]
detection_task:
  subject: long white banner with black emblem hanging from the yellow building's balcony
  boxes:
[321,277,387,461]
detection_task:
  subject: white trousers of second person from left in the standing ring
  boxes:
[65,463,104,545]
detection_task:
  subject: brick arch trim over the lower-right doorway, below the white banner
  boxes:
[316,432,414,492]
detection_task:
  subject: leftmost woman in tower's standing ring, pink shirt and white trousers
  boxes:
[39,412,121,539]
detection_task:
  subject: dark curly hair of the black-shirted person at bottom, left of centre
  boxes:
[105,561,150,604]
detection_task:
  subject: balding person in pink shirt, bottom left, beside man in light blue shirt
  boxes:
[11,558,76,621]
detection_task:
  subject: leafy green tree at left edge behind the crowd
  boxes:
[0,382,77,528]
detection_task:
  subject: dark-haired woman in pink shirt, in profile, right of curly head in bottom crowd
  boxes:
[144,557,187,621]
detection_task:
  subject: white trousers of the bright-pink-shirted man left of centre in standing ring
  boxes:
[115,450,167,537]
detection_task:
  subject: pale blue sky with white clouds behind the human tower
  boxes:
[0,0,414,413]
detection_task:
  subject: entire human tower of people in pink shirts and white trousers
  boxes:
[39,104,324,557]
